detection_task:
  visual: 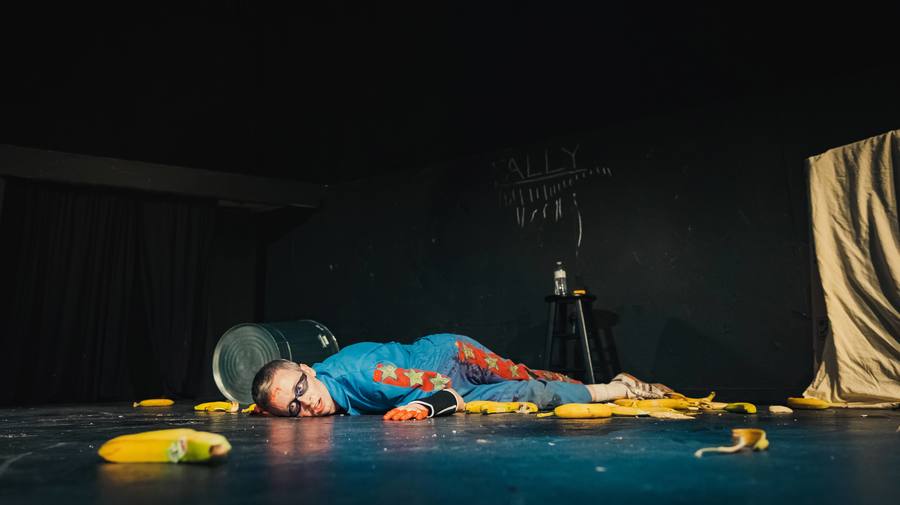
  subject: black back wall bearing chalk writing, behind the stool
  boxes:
[265,72,900,398]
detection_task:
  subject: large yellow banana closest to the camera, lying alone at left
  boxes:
[97,428,231,463]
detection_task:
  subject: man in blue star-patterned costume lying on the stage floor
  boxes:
[252,333,671,421]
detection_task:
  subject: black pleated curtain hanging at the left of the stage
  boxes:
[0,180,216,405]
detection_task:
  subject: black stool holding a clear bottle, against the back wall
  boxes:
[544,295,621,384]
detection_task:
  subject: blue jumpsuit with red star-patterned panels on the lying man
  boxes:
[313,333,591,415]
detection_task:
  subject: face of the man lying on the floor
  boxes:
[269,364,337,417]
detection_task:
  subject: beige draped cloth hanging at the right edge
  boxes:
[804,130,900,402]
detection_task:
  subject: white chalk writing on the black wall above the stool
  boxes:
[491,144,612,255]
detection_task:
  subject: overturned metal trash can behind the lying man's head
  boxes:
[212,319,339,403]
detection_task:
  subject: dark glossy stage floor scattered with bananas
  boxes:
[0,404,900,505]
